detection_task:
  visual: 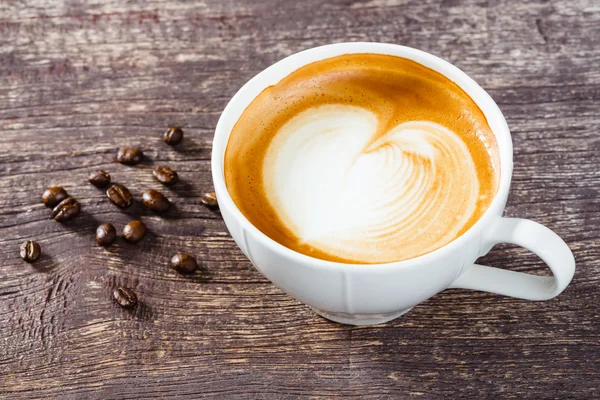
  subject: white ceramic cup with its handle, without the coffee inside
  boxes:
[212,43,575,325]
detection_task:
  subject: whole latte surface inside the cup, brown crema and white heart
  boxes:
[225,54,499,264]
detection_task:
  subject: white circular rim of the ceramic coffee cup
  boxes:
[211,42,513,271]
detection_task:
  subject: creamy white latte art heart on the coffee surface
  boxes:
[263,105,479,262]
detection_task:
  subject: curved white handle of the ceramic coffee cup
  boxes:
[449,218,575,300]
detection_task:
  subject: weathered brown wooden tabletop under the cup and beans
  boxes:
[0,0,600,399]
